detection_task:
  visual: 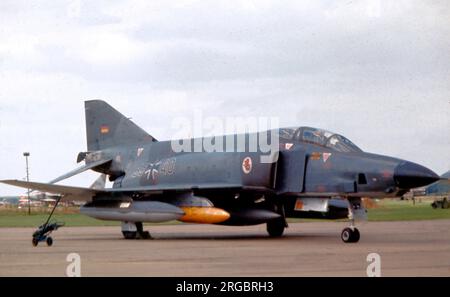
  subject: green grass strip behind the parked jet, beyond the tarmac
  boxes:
[0,199,450,227]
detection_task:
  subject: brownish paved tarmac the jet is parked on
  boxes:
[0,220,450,276]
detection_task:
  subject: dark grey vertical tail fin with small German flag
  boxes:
[85,100,156,151]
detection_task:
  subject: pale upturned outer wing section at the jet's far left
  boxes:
[0,180,103,201]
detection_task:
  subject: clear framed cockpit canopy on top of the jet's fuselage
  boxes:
[280,127,362,153]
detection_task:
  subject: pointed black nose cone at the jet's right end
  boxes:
[394,161,439,189]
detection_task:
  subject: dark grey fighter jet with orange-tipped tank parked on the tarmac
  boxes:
[1,100,439,243]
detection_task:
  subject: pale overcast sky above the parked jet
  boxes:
[0,0,450,196]
